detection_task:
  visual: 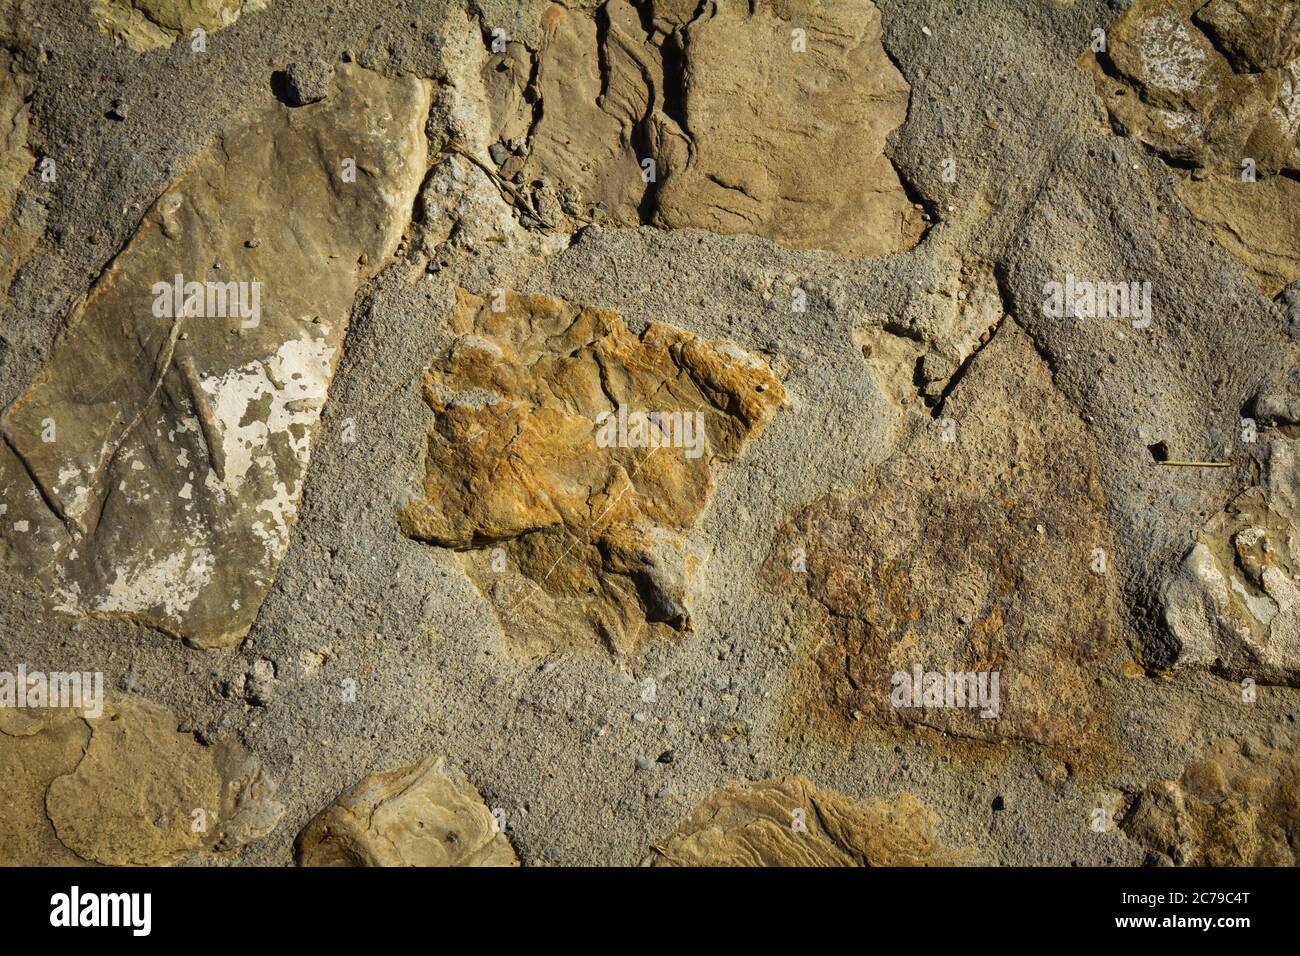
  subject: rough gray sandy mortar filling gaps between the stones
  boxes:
[0,0,1300,865]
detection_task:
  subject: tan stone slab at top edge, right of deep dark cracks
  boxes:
[655,0,923,255]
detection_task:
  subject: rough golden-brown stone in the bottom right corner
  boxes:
[1122,735,1300,866]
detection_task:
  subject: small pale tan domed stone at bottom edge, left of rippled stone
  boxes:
[296,757,519,866]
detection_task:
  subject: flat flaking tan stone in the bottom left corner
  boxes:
[0,697,283,866]
